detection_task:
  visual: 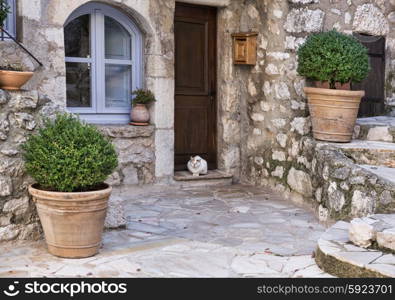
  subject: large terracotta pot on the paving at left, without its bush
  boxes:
[29,184,112,258]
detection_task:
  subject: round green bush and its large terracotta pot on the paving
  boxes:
[22,114,118,258]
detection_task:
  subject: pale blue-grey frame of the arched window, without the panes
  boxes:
[64,3,143,124]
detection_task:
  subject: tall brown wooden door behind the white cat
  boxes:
[174,3,217,170]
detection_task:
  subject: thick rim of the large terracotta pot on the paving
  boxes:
[29,183,112,201]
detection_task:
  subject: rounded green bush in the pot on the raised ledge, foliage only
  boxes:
[298,31,369,89]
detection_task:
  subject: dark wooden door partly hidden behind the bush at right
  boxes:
[352,34,385,117]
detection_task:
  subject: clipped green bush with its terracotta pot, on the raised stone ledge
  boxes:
[298,31,369,142]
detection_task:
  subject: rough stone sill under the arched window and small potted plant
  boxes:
[97,124,155,139]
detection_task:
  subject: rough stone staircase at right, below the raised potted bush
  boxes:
[313,117,395,220]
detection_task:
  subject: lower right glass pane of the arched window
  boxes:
[106,64,131,108]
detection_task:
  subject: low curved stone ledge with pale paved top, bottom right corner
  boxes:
[315,221,395,278]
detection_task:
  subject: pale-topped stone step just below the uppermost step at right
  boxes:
[333,140,395,168]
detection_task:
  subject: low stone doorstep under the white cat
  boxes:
[174,170,233,187]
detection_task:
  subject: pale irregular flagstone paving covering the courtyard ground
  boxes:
[0,185,330,277]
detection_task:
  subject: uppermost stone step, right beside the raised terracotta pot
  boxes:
[354,116,395,143]
